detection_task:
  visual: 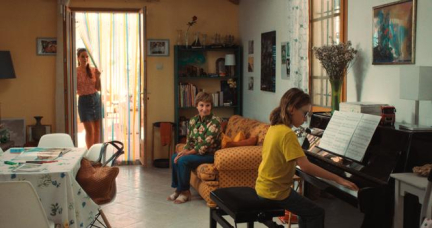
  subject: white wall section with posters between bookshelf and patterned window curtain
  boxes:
[239,0,292,122]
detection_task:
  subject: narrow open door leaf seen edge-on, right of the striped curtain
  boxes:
[139,7,147,166]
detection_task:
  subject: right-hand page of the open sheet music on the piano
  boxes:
[345,114,381,161]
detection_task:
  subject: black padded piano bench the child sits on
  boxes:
[210,187,285,228]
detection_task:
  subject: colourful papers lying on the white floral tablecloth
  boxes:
[12,147,70,162]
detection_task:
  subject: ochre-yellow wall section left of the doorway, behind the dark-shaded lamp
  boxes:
[0,0,57,131]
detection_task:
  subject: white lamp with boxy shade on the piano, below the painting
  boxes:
[399,66,432,130]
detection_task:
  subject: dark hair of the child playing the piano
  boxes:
[270,88,311,126]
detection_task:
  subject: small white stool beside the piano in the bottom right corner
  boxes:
[390,173,428,228]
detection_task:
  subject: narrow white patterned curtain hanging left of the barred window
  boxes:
[288,0,309,93]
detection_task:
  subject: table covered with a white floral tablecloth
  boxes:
[0,148,99,228]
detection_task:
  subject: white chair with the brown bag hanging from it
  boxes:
[84,141,124,227]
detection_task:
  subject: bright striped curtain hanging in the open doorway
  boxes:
[76,13,140,164]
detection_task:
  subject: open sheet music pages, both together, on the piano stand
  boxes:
[319,111,381,161]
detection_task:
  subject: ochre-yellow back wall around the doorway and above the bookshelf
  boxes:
[0,0,239,162]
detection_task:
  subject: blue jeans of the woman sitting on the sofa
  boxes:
[171,154,214,192]
